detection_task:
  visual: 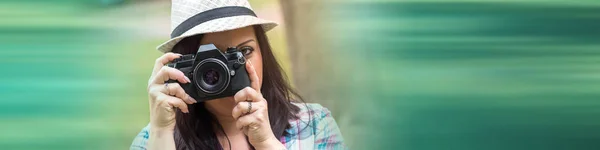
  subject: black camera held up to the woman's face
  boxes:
[167,44,250,102]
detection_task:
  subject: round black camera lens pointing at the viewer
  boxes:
[194,58,229,95]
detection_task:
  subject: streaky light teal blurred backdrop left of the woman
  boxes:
[0,0,168,150]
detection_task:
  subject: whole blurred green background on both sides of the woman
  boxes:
[0,0,600,150]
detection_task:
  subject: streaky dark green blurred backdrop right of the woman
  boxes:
[323,0,600,150]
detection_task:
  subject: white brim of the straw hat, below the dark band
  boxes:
[156,16,277,53]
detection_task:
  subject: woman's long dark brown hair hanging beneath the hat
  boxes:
[172,26,302,150]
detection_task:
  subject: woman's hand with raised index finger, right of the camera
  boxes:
[232,61,285,149]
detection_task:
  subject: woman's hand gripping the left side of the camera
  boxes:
[148,53,197,131]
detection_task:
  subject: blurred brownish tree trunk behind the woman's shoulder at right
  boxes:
[280,0,335,111]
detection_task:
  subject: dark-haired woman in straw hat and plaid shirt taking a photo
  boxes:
[131,0,346,150]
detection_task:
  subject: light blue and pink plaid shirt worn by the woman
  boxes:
[130,103,348,150]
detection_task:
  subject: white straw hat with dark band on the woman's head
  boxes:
[156,0,277,52]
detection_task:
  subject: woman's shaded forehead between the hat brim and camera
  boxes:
[200,26,256,48]
